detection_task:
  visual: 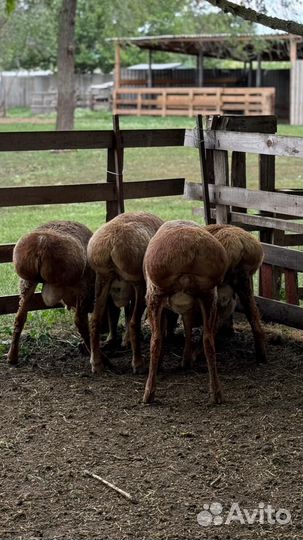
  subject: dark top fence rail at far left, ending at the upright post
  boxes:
[0,130,113,152]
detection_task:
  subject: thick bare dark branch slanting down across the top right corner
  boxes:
[203,0,303,36]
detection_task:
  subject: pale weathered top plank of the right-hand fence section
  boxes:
[184,129,303,158]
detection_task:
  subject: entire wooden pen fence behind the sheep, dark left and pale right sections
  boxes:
[0,116,303,329]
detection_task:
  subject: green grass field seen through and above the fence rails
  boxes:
[0,109,303,338]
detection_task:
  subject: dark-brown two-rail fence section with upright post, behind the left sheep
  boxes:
[0,119,185,315]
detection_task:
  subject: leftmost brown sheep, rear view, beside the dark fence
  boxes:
[8,221,95,364]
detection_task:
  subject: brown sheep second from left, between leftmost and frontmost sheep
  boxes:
[87,212,163,374]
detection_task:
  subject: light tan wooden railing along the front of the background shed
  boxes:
[113,87,275,117]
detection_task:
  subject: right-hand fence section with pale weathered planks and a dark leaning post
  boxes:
[185,117,303,329]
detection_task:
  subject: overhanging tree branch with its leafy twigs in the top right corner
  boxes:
[202,0,303,36]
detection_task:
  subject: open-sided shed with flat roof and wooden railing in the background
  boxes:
[113,34,303,123]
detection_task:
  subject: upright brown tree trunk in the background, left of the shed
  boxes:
[56,0,77,131]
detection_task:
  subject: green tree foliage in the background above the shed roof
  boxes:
[0,0,251,73]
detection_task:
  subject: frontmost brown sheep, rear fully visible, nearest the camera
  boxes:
[143,220,227,403]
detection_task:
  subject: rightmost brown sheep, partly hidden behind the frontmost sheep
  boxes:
[205,224,266,363]
